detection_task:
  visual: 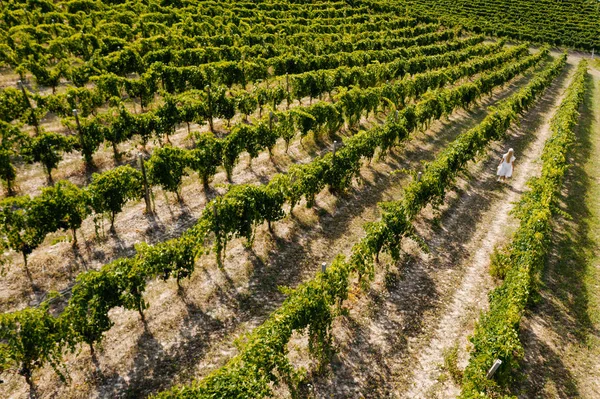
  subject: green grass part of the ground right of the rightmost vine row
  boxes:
[555,67,600,351]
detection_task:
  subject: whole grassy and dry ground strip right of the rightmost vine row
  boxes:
[515,60,600,399]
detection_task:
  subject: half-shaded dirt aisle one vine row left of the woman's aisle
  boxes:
[0,68,527,397]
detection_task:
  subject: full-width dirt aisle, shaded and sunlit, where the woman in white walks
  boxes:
[296,57,567,398]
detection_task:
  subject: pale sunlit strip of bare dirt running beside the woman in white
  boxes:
[403,54,571,398]
